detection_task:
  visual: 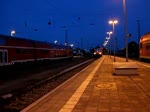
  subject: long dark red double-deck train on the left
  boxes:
[0,35,73,66]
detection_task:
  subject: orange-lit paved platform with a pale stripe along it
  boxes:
[21,56,150,112]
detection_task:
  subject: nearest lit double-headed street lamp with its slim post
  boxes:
[109,20,118,62]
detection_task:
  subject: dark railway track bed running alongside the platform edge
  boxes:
[0,59,93,112]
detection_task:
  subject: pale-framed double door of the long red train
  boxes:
[0,50,8,66]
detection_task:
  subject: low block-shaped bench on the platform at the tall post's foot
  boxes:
[113,62,138,75]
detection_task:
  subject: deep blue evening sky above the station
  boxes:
[0,0,150,48]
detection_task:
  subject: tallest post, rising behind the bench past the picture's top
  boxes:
[123,0,128,62]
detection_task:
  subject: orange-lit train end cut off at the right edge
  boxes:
[140,32,150,59]
